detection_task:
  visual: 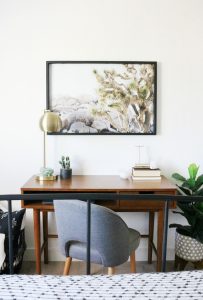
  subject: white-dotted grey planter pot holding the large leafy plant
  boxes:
[175,231,203,261]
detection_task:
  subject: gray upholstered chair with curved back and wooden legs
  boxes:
[54,200,140,275]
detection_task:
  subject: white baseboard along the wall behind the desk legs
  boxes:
[24,247,175,261]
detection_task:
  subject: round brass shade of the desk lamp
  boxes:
[39,110,62,132]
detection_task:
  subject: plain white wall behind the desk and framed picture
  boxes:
[0,0,203,260]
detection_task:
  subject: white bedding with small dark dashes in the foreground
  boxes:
[0,271,203,300]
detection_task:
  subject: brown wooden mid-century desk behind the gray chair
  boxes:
[21,175,176,274]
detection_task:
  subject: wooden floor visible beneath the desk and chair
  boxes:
[21,261,191,275]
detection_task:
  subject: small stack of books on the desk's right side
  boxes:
[132,164,161,181]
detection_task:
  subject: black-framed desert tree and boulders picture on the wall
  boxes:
[46,61,157,135]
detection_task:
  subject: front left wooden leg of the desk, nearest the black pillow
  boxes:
[33,209,41,274]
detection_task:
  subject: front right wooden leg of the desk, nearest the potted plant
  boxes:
[156,210,164,272]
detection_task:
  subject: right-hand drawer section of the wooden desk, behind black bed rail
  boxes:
[119,191,175,211]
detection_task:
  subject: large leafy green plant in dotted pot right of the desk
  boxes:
[169,163,203,262]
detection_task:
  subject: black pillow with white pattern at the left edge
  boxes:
[0,209,26,273]
